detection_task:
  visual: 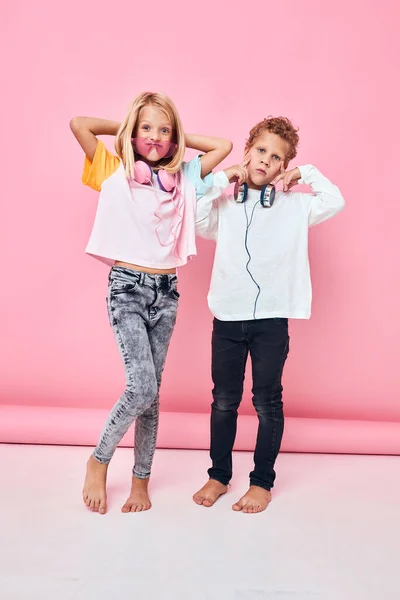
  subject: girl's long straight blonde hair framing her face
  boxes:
[115,92,186,178]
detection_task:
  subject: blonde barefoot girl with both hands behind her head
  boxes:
[70,93,232,514]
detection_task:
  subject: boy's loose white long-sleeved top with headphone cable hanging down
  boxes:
[196,165,344,321]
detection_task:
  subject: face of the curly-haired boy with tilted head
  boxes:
[246,131,289,189]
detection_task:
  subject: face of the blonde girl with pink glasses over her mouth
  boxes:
[133,104,176,163]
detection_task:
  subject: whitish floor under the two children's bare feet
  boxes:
[0,445,400,600]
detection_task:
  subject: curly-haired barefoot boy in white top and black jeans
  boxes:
[193,117,344,513]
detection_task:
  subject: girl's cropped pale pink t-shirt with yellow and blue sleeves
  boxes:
[82,141,212,269]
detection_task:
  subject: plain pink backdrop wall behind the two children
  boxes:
[0,0,400,440]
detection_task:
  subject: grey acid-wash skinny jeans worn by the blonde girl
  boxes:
[93,267,179,479]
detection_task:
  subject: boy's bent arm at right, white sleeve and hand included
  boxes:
[274,165,344,227]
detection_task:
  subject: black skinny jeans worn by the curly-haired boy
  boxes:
[208,318,289,490]
